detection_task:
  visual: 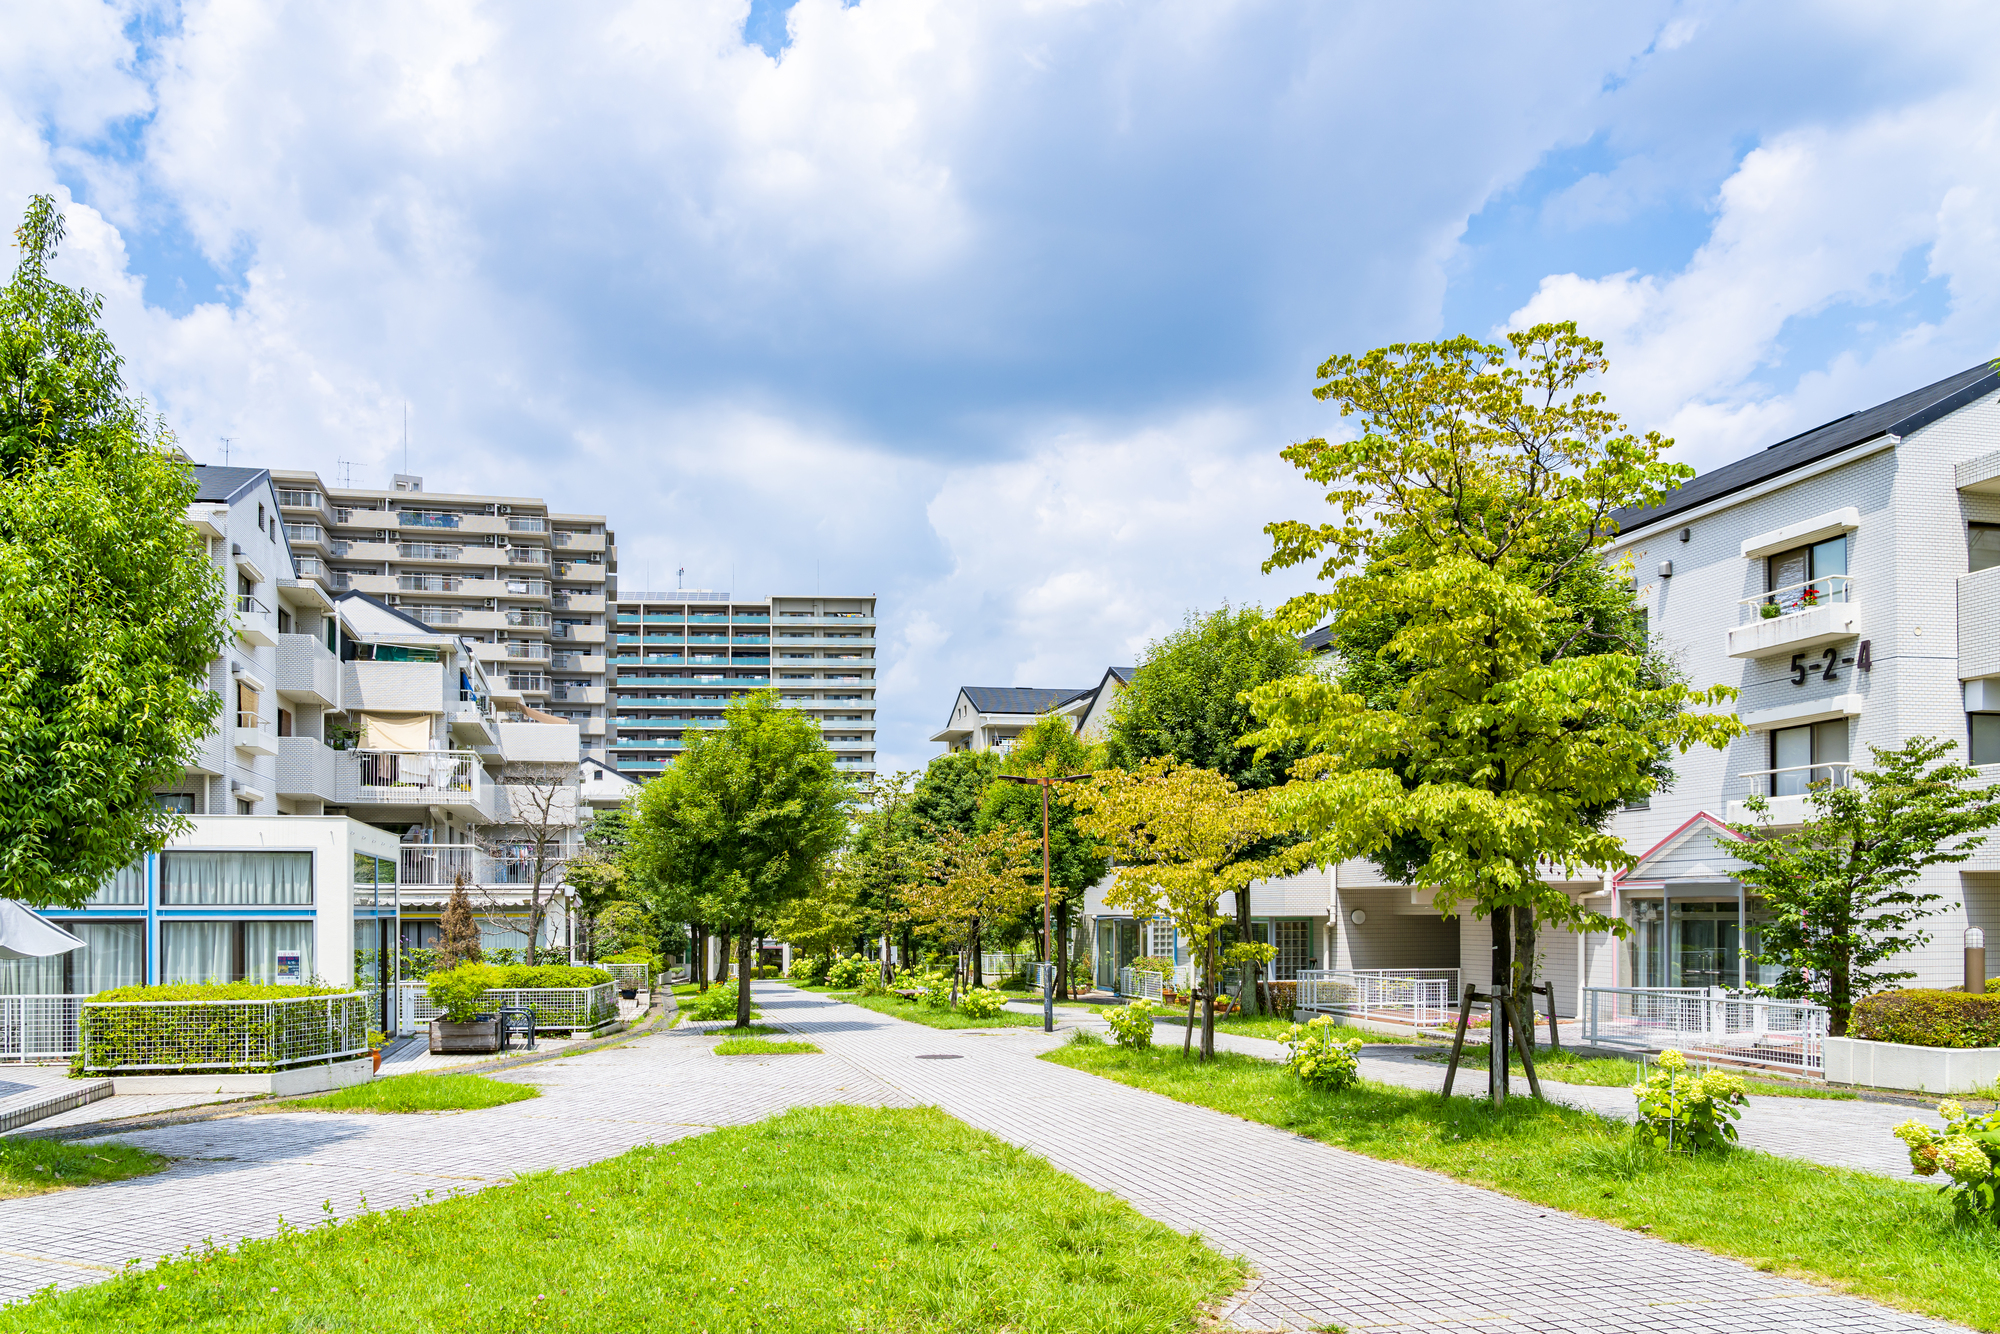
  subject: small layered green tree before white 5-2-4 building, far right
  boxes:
[1732,736,2000,1038]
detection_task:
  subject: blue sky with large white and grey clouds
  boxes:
[11,0,2000,764]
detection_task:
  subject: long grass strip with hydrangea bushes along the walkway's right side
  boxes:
[1042,1046,2000,1330]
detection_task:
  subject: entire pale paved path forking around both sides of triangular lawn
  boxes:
[0,984,1956,1334]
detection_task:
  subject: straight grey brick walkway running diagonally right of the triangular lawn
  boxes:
[776,986,1954,1334]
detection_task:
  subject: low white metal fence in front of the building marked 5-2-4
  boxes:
[1582,986,1826,1076]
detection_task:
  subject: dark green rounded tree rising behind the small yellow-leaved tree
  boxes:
[1104,604,1310,1012]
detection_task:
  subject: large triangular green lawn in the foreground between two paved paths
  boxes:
[0,1106,1244,1334]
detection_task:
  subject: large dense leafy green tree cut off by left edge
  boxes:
[0,196,228,908]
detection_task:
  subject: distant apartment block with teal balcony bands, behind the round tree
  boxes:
[610,588,876,778]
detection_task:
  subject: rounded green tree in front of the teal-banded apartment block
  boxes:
[628,690,852,1028]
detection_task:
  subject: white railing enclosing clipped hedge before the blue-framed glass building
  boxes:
[78,992,370,1074]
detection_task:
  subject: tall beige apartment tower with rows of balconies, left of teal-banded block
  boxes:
[272,472,618,760]
